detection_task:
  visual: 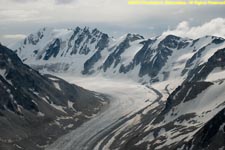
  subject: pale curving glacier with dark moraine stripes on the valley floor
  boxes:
[47,75,163,150]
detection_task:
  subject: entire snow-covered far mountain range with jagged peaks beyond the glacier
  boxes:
[11,27,225,83]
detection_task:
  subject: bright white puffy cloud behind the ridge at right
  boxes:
[163,18,225,39]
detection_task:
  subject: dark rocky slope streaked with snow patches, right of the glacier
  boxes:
[91,48,225,150]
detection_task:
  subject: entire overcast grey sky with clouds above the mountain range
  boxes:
[0,0,225,44]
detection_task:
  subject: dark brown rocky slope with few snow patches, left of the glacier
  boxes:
[0,45,107,150]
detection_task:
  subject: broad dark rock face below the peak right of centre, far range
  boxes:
[133,35,189,81]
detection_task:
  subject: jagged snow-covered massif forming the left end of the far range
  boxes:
[11,27,113,73]
